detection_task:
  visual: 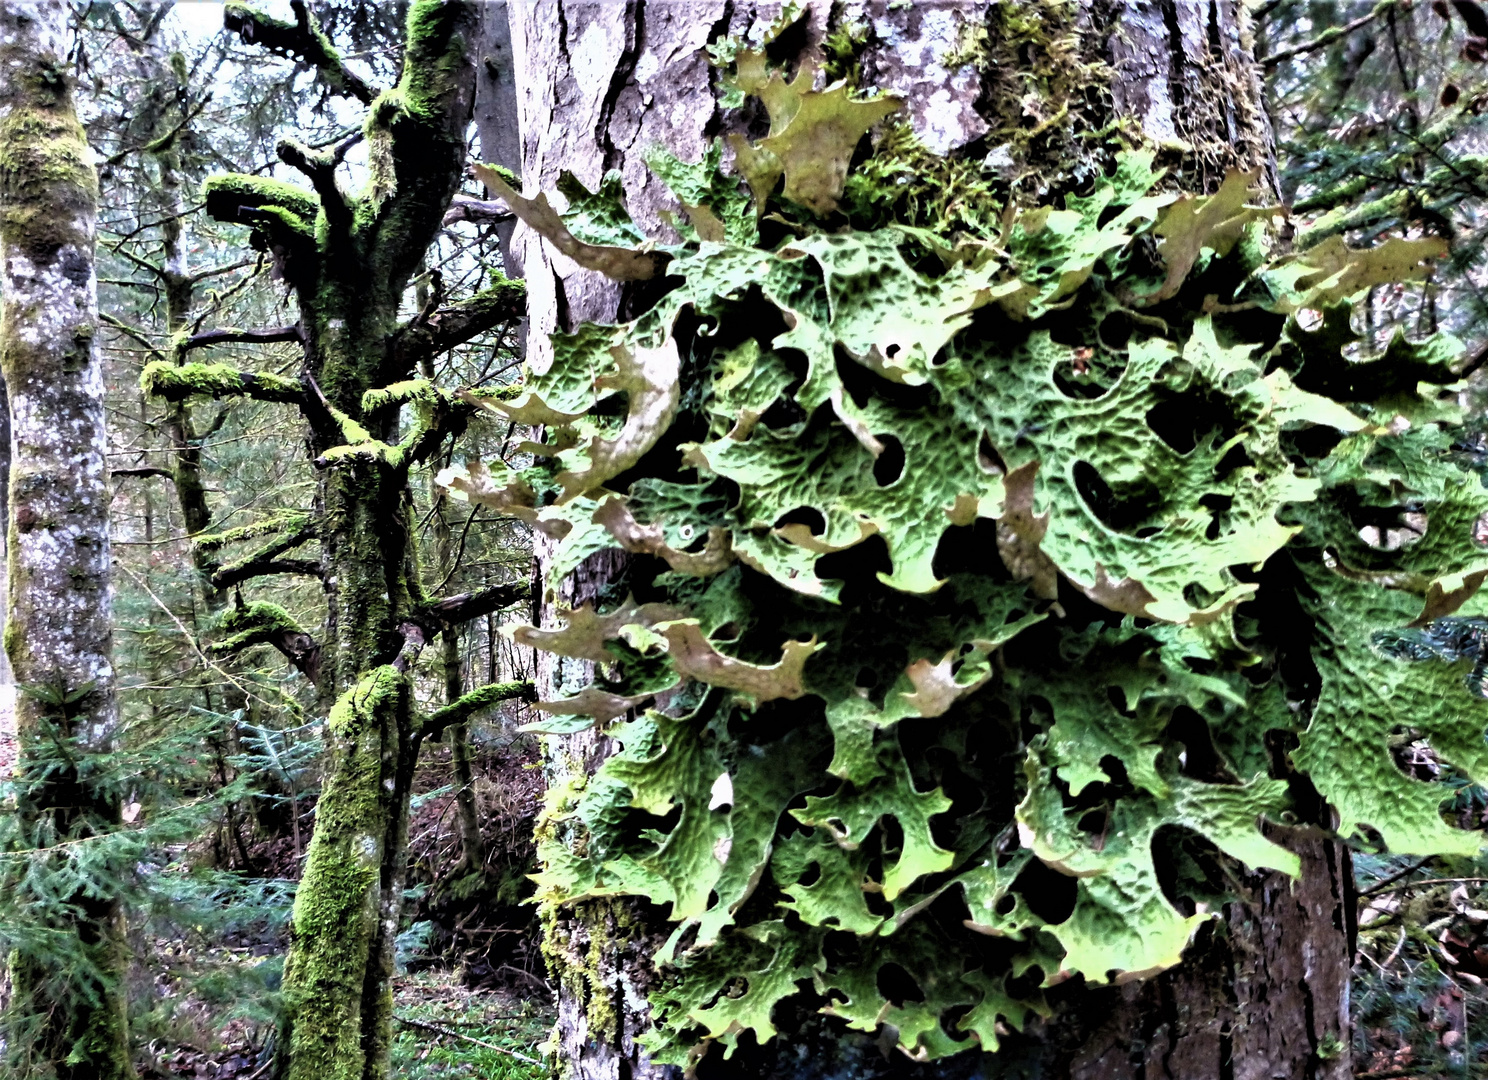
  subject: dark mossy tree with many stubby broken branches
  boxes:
[130,3,524,1077]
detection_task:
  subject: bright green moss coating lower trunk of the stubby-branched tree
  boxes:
[284,665,411,1080]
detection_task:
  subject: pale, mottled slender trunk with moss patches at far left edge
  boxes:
[0,0,132,1080]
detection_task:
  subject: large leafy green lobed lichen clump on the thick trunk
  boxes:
[479,57,1488,1065]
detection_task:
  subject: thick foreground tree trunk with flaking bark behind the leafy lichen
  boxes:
[512,0,1353,1080]
